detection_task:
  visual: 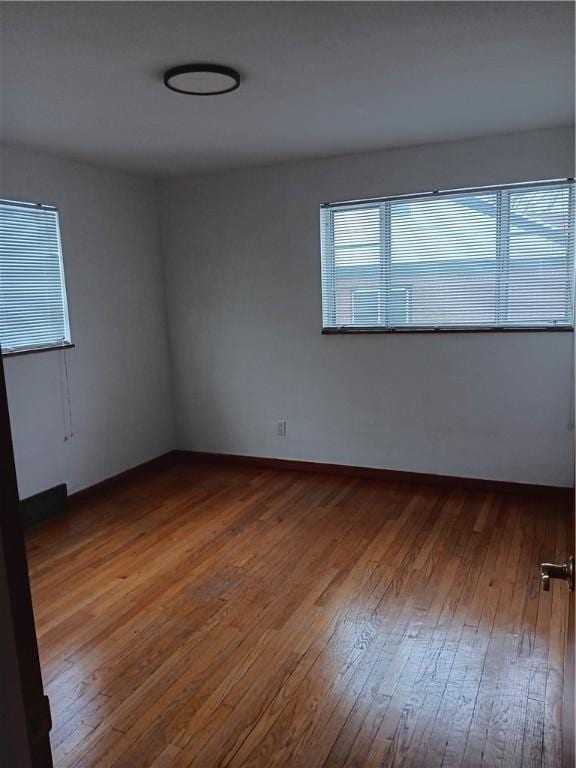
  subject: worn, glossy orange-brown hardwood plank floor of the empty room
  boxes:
[28,466,568,768]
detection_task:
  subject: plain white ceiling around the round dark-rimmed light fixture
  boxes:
[1,0,574,175]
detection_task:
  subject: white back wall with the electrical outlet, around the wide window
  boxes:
[160,129,574,485]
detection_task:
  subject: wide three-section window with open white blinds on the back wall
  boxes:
[320,180,575,331]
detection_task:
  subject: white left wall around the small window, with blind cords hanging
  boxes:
[0,147,173,497]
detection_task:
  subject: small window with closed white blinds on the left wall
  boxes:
[0,200,70,353]
